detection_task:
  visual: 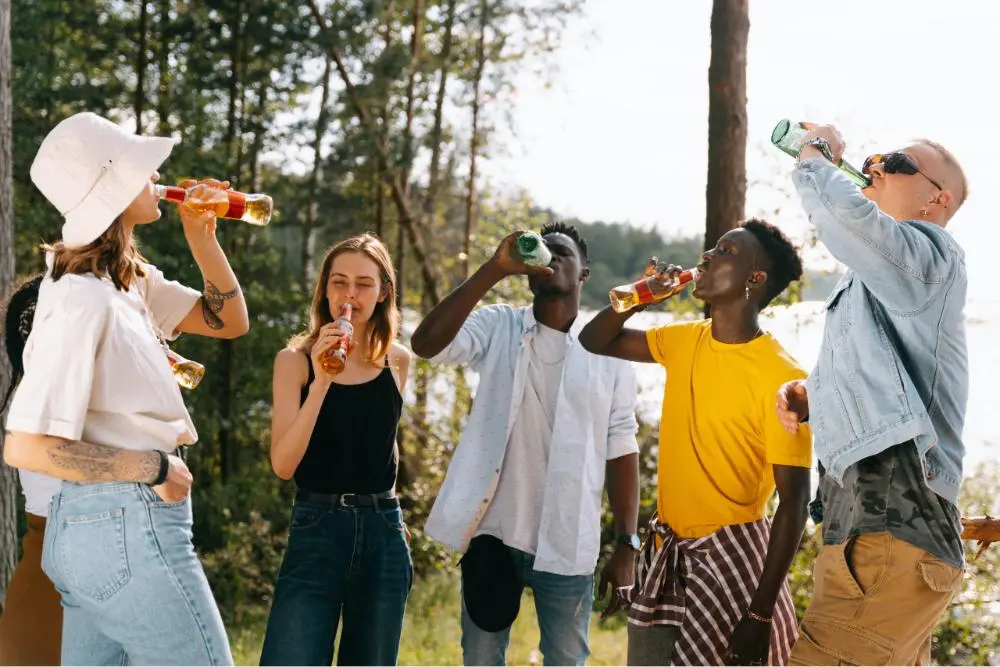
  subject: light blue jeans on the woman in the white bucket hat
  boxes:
[42,482,233,665]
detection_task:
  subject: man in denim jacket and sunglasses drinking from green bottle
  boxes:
[778,126,969,664]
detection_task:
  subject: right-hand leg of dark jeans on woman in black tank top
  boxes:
[337,508,413,665]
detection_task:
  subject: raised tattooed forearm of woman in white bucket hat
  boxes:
[173,180,250,338]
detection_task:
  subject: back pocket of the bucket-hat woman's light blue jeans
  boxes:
[53,507,132,602]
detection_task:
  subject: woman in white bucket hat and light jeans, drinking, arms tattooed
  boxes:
[4,113,249,665]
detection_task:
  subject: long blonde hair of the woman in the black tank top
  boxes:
[288,233,400,364]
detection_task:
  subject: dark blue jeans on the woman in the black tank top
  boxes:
[260,502,413,665]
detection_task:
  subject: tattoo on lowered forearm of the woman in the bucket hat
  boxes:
[49,441,160,484]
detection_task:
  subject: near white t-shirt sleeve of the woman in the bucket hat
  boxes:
[7,299,112,440]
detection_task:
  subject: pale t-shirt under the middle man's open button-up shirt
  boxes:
[476,322,569,554]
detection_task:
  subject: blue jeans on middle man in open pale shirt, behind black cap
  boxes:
[462,547,594,665]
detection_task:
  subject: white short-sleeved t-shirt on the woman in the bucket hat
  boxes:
[7,264,201,517]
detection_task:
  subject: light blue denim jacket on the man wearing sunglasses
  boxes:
[793,158,969,503]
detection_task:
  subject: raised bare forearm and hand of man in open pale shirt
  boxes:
[410,232,552,359]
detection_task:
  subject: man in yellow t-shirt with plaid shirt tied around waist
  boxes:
[580,220,812,665]
